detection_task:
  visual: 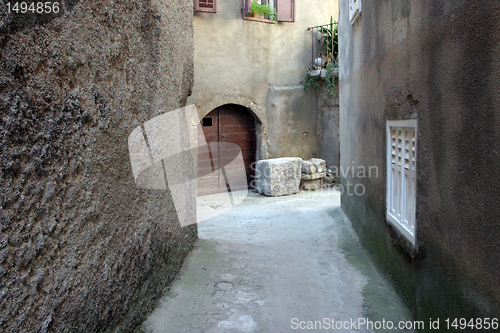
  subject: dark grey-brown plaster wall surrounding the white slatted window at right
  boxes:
[339,0,500,320]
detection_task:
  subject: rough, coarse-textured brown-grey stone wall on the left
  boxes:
[0,0,197,332]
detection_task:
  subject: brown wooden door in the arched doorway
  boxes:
[197,104,256,195]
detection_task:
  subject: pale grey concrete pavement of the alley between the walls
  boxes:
[143,190,411,333]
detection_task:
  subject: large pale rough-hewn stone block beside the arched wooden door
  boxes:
[255,157,302,197]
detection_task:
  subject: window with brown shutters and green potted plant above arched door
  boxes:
[242,0,295,22]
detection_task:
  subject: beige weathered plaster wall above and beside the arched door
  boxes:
[188,0,338,159]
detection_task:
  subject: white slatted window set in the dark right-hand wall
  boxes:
[386,119,417,245]
